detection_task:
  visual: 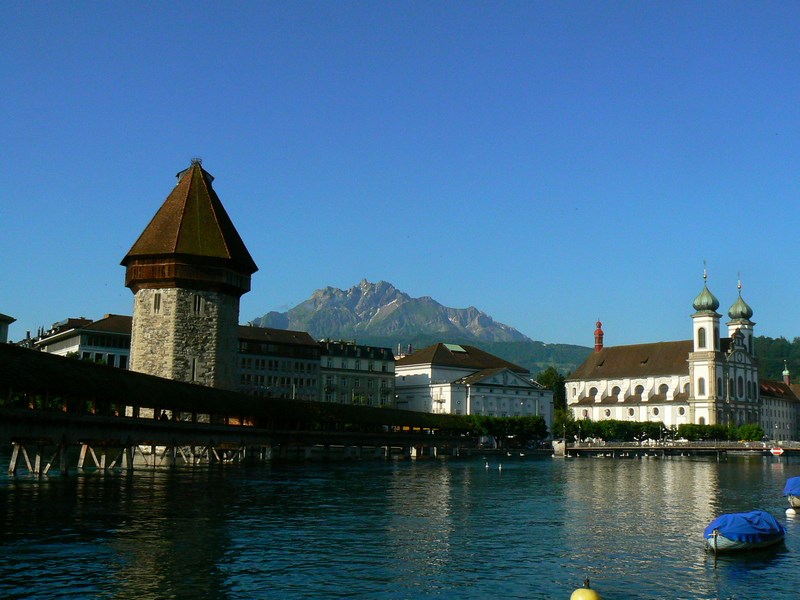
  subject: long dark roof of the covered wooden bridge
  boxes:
[0,343,469,430]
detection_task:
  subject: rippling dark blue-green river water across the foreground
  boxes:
[0,454,800,600]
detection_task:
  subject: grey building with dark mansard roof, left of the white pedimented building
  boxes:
[318,340,395,407]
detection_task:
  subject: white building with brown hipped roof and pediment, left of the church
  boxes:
[395,343,553,430]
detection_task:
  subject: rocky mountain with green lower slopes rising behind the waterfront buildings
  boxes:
[251,280,590,375]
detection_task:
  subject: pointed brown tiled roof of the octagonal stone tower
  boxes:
[122,159,258,275]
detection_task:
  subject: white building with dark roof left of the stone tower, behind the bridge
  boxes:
[33,314,131,369]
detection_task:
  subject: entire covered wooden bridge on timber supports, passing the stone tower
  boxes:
[0,344,475,474]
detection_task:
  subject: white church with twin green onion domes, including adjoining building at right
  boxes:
[566,273,800,439]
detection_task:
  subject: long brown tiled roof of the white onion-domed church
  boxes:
[569,340,693,381]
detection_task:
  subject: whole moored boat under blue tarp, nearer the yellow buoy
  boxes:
[703,510,786,552]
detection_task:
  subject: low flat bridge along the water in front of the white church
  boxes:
[566,440,800,459]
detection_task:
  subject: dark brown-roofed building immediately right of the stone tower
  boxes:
[239,326,321,401]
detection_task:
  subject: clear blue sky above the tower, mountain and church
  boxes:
[0,1,800,346]
